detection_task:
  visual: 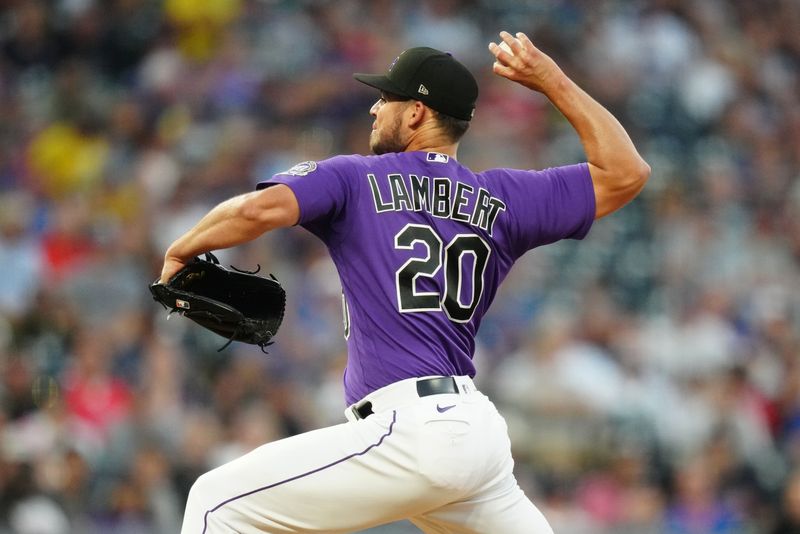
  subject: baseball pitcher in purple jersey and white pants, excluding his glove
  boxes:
[161,32,650,534]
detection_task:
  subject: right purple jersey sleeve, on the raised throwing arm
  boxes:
[484,163,595,256]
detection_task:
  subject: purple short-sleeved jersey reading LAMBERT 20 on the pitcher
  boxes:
[258,152,595,403]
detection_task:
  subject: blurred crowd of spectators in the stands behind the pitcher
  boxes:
[0,0,800,534]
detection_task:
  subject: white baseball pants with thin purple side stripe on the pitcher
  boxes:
[181,377,553,534]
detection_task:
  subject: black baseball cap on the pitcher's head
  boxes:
[353,46,478,121]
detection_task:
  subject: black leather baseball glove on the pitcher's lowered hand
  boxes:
[150,252,286,352]
